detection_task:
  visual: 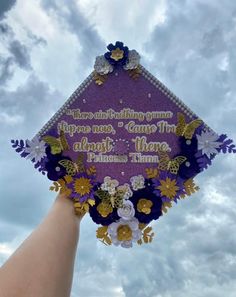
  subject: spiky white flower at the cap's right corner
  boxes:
[197,131,222,158]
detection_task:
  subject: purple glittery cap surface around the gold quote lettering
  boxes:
[43,68,196,184]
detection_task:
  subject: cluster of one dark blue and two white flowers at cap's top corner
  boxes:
[94,41,140,75]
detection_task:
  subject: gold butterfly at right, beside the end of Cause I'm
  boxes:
[175,112,202,139]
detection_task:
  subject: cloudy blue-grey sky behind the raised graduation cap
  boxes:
[0,0,236,297]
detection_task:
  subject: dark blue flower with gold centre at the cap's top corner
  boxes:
[104,41,129,65]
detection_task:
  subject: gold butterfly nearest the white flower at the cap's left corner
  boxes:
[42,130,70,155]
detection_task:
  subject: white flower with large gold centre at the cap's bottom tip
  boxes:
[107,218,142,248]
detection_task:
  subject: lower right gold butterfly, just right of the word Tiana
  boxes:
[158,151,187,174]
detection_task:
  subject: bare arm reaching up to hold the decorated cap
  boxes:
[0,195,81,297]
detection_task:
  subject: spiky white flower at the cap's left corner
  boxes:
[24,136,46,163]
